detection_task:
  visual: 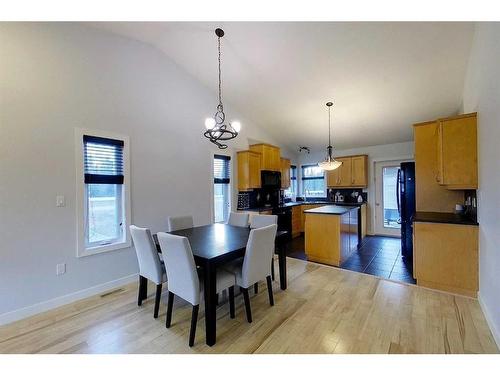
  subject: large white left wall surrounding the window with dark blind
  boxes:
[0,23,294,323]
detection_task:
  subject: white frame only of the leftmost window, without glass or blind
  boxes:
[75,128,131,258]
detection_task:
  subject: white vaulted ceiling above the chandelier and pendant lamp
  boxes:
[88,22,474,150]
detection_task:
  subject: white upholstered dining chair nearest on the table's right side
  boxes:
[223,224,278,323]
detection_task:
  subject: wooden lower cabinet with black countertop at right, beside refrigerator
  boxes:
[413,222,479,297]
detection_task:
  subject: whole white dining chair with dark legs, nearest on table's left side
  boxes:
[158,232,236,346]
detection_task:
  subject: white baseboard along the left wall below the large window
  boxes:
[0,273,138,326]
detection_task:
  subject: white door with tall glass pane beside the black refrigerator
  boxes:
[375,160,404,237]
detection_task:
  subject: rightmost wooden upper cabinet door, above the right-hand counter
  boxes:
[437,113,478,190]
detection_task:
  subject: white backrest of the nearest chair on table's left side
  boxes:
[158,232,200,306]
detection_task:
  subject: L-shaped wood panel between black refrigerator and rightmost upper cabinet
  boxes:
[413,121,464,212]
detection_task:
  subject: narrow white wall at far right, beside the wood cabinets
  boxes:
[463,23,500,347]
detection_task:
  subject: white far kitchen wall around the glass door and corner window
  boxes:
[298,142,414,234]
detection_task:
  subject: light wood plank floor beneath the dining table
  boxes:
[0,258,498,353]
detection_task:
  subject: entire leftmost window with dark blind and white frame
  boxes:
[77,129,130,256]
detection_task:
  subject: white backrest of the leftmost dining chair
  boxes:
[129,225,163,285]
